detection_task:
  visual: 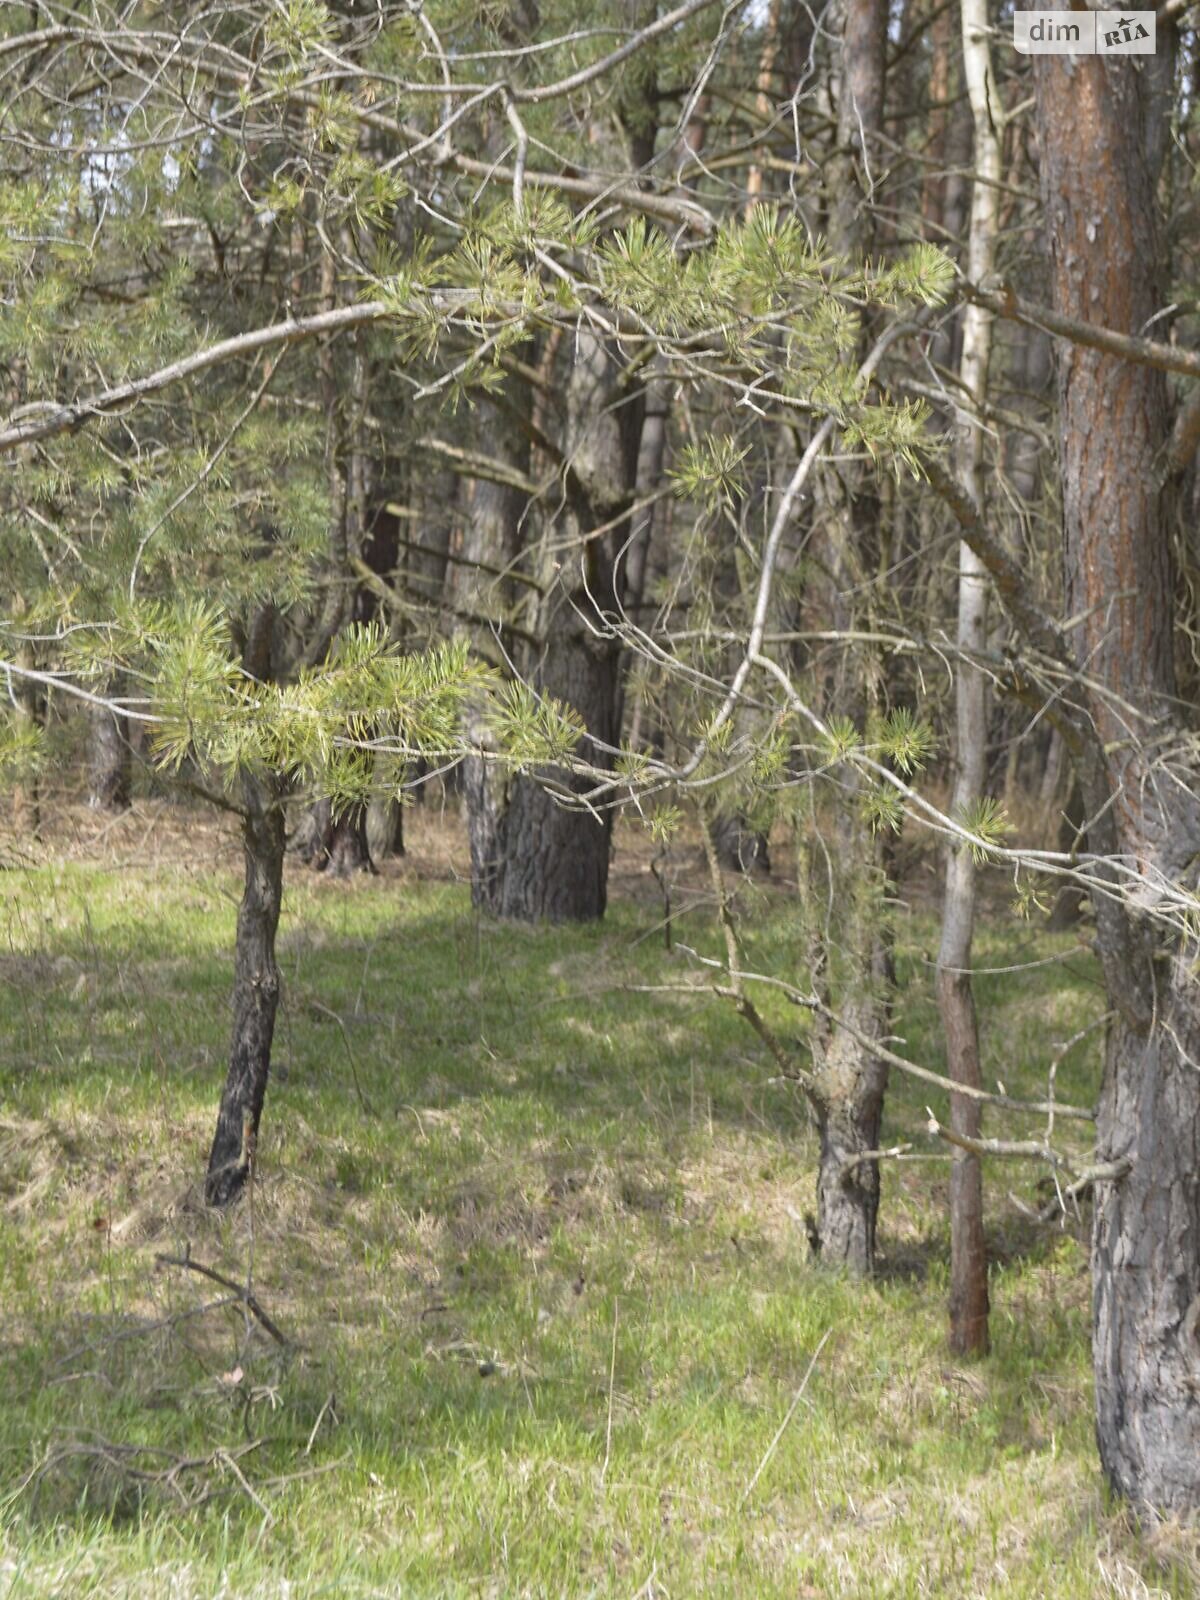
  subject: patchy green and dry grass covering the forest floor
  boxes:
[0,802,1197,1600]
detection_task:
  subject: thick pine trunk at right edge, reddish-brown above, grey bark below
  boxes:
[1034,42,1200,1514]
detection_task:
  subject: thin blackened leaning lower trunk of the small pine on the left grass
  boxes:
[205,776,285,1206]
